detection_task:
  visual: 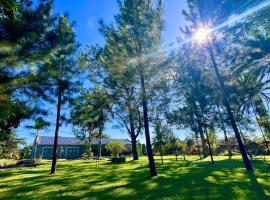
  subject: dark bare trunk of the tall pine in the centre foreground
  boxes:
[140,66,157,177]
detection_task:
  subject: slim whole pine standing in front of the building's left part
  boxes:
[32,16,80,174]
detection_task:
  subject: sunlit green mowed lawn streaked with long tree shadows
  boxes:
[0,156,270,200]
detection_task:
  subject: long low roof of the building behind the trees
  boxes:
[36,136,131,145]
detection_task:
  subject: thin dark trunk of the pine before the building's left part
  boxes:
[51,88,62,174]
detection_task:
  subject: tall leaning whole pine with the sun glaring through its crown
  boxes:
[181,0,253,171]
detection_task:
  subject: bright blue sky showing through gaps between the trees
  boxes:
[16,0,188,143]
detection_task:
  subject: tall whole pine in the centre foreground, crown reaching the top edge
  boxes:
[112,0,163,176]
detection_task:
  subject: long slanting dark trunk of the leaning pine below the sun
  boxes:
[208,42,253,171]
